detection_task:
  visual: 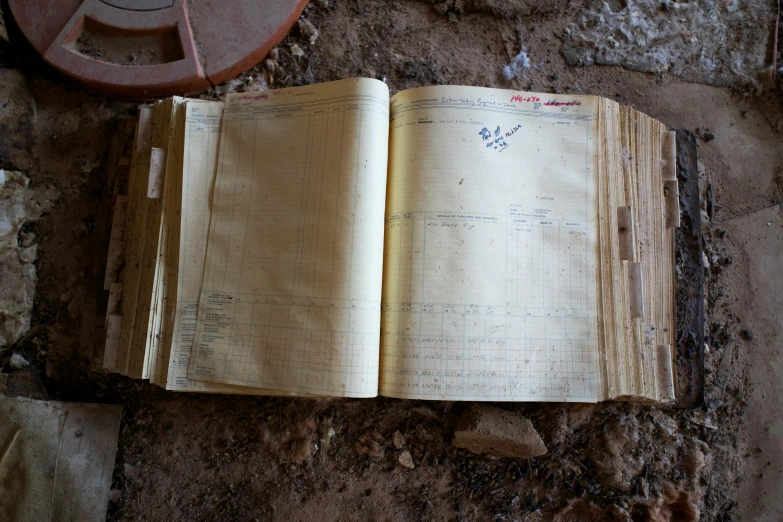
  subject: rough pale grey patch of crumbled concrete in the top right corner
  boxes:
[561,0,775,88]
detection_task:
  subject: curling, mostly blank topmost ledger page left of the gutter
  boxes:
[187,79,389,397]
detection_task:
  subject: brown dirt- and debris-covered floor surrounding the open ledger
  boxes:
[0,0,783,522]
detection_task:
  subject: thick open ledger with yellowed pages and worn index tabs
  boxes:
[105,79,679,402]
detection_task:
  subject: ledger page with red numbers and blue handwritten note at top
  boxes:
[380,87,602,402]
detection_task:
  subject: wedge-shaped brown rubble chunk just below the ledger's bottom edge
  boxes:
[452,404,547,458]
